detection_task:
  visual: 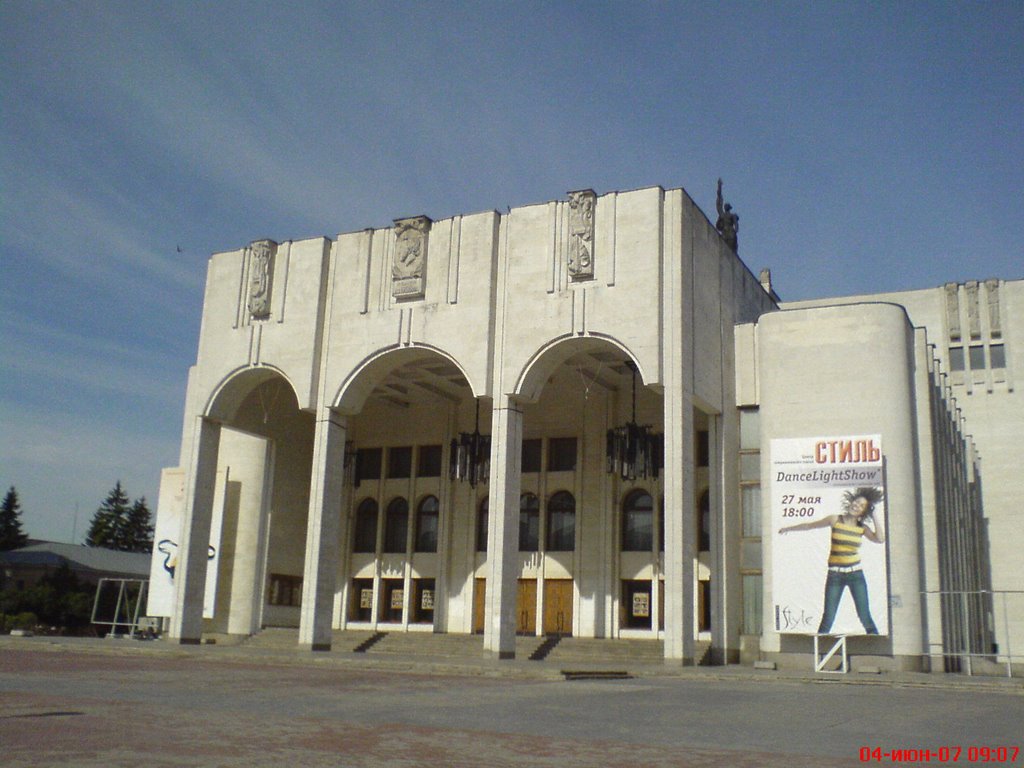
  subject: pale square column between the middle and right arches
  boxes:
[483,397,522,658]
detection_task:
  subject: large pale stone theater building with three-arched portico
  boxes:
[150,187,1024,669]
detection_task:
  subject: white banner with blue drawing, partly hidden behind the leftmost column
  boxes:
[146,469,228,618]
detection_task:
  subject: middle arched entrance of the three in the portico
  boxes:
[333,347,481,632]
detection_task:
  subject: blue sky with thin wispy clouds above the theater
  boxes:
[0,0,1024,541]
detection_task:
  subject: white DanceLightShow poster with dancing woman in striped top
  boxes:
[770,434,889,635]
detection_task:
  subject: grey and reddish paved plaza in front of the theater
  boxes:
[0,638,1024,768]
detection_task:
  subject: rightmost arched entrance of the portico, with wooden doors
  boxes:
[519,337,664,637]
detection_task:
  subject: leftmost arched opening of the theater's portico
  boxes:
[167,367,313,642]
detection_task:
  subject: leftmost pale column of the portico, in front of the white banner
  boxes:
[169,417,220,645]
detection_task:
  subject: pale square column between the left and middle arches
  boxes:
[299,408,347,650]
